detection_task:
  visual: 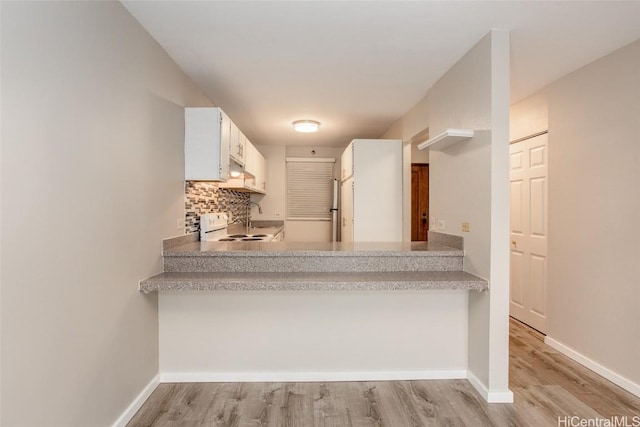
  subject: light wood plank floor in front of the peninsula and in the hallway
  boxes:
[128,319,640,427]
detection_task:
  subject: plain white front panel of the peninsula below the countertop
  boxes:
[160,291,467,381]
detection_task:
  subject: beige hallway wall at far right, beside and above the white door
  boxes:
[512,41,640,394]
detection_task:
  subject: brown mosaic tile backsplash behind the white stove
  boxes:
[184,181,249,233]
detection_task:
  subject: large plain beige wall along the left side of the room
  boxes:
[0,2,209,427]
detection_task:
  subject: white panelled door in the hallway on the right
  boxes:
[509,134,548,333]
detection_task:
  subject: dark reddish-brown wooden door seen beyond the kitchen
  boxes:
[411,163,429,242]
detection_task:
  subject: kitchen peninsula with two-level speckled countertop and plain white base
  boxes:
[139,233,488,382]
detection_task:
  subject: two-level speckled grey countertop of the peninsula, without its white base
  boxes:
[140,231,487,293]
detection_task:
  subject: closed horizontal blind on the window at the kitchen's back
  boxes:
[287,158,335,221]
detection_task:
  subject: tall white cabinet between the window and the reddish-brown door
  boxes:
[340,139,403,242]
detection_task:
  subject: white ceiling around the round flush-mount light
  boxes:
[123,1,640,146]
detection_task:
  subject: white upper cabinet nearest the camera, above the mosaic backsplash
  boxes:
[184,108,231,181]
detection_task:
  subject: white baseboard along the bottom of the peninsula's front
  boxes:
[160,369,467,383]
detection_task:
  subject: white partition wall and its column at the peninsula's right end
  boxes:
[384,31,511,400]
